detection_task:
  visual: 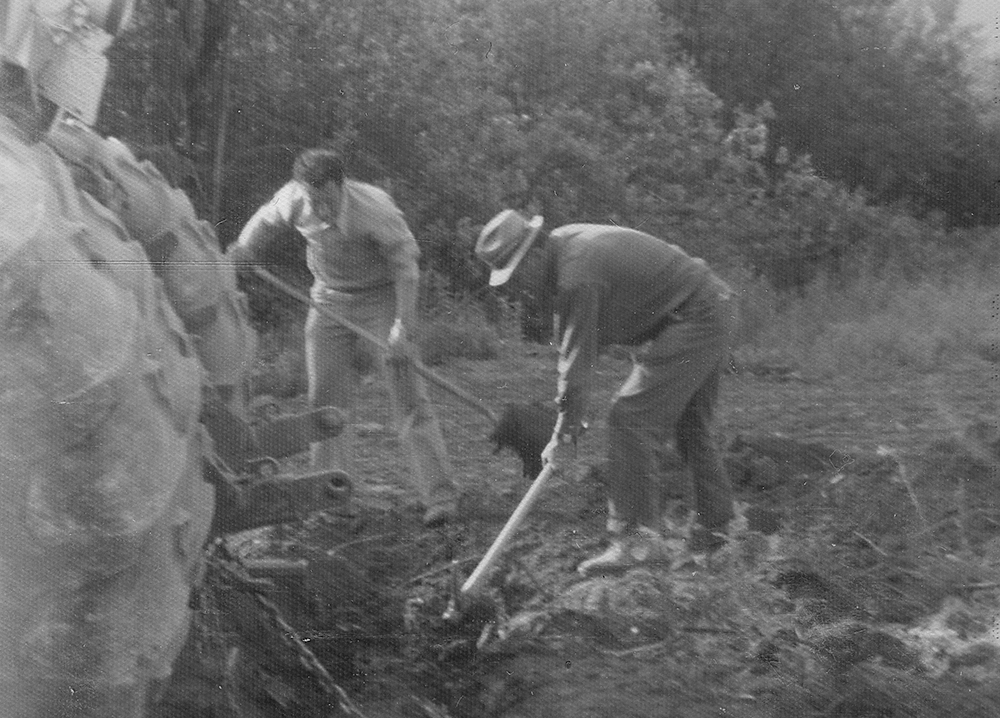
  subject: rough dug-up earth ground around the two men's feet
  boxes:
[157,343,1000,718]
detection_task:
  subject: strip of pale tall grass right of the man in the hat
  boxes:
[737,268,1000,377]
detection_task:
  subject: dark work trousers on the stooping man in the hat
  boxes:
[606,279,735,531]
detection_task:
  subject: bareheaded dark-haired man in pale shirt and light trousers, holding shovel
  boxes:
[228,149,456,526]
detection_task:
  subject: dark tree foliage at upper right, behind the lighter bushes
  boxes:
[659,0,1000,226]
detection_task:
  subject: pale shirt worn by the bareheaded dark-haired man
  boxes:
[236,179,420,302]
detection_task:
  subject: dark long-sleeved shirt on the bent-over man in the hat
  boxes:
[546,224,714,432]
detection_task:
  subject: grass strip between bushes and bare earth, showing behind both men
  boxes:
[248,256,1000,396]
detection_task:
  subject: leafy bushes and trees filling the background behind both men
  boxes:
[100,0,1000,374]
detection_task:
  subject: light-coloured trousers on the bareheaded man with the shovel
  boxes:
[305,286,456,506]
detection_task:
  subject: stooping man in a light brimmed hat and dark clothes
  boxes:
[476,209,733,575]
